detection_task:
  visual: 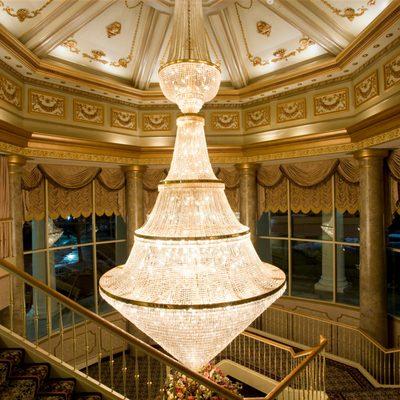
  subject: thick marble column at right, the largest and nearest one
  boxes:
[355,149,388,346]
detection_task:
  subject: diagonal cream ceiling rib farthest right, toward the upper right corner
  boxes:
[260,0,346,56]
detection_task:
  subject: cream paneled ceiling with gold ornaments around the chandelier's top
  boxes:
[0,0,400,101]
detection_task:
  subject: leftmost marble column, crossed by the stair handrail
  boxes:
[4,155,26,334]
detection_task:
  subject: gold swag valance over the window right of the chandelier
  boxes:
[257,159,360,215]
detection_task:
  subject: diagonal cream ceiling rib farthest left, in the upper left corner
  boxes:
[30,0,118,57]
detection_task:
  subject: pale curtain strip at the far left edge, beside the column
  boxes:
[0,156,13,258]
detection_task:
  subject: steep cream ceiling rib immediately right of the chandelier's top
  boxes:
[208,10,249,89]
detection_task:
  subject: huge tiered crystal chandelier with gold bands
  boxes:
[100,0,286,370]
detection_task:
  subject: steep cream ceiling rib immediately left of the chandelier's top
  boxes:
[132,8,171,90]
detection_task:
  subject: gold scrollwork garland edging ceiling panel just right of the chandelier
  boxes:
[235,0,315,67]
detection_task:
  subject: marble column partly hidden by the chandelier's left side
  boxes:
[124,165,146,253]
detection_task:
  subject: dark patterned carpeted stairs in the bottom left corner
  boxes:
[0,348,102,400]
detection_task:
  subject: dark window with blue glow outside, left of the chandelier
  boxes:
[23,180,127,335]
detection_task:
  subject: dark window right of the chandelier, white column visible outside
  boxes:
[257,174,360,306]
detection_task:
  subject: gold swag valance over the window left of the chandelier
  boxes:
[22,164,125,221]
